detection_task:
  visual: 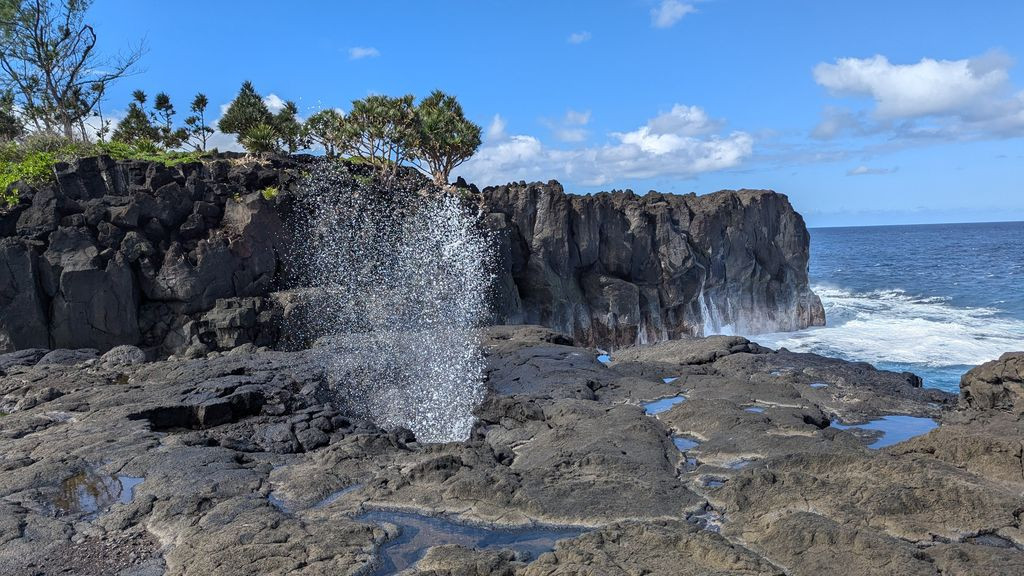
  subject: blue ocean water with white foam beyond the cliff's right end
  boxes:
[752,222,1024,392]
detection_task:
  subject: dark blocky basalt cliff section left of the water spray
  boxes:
[0,157,298,356]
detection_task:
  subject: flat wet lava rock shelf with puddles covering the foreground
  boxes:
[0,326,1024,576]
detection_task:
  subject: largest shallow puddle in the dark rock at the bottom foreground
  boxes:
[355,510,585,574]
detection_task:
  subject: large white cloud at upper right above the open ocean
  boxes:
[812,52,1024,139]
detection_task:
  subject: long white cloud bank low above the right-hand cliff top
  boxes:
[460,101,754,186]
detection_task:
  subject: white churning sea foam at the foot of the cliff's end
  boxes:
[751,286,1024,367]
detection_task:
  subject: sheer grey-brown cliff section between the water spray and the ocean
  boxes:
[482,181,824,346]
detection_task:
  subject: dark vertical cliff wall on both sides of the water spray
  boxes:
[0,158,823,356]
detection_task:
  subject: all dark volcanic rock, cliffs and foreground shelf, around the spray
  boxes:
[0,157,1024,576]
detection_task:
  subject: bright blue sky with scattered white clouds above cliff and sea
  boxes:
[90,0,1024,227]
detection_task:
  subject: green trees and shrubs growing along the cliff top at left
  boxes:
[0,0,481,207]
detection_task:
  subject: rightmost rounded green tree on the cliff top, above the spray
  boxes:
[416,90,480,186]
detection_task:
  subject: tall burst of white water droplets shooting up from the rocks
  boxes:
[293,161,492,442]
